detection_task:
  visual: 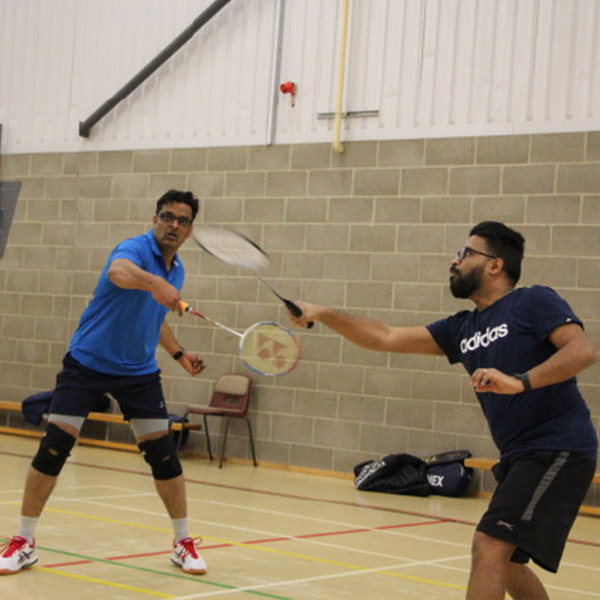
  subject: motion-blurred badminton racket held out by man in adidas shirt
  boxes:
[192,225,313,329]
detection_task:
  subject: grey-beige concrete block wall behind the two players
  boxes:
[0,132,600,494]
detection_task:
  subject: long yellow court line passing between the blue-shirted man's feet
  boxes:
[46,508,466,590]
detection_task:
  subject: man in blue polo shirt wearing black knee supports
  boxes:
[0,190,206,575]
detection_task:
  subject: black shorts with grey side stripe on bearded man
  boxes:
[477,451,596,573]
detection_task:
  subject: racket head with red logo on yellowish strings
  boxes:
[240,321,300,377]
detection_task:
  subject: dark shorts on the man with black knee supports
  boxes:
[50,354,168,419]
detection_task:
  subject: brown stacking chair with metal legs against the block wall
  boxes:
[184,374,258,468]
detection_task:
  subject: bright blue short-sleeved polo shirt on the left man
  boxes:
[69,230,185,375]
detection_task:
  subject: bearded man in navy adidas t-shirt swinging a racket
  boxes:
[290,221,598,600]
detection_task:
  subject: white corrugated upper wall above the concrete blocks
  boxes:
[0,0,600,152]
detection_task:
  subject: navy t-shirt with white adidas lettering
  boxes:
[427,285,598,460]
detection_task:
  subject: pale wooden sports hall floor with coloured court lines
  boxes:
[0,435,600,600]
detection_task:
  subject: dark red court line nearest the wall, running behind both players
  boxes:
[0,450,600,548]
